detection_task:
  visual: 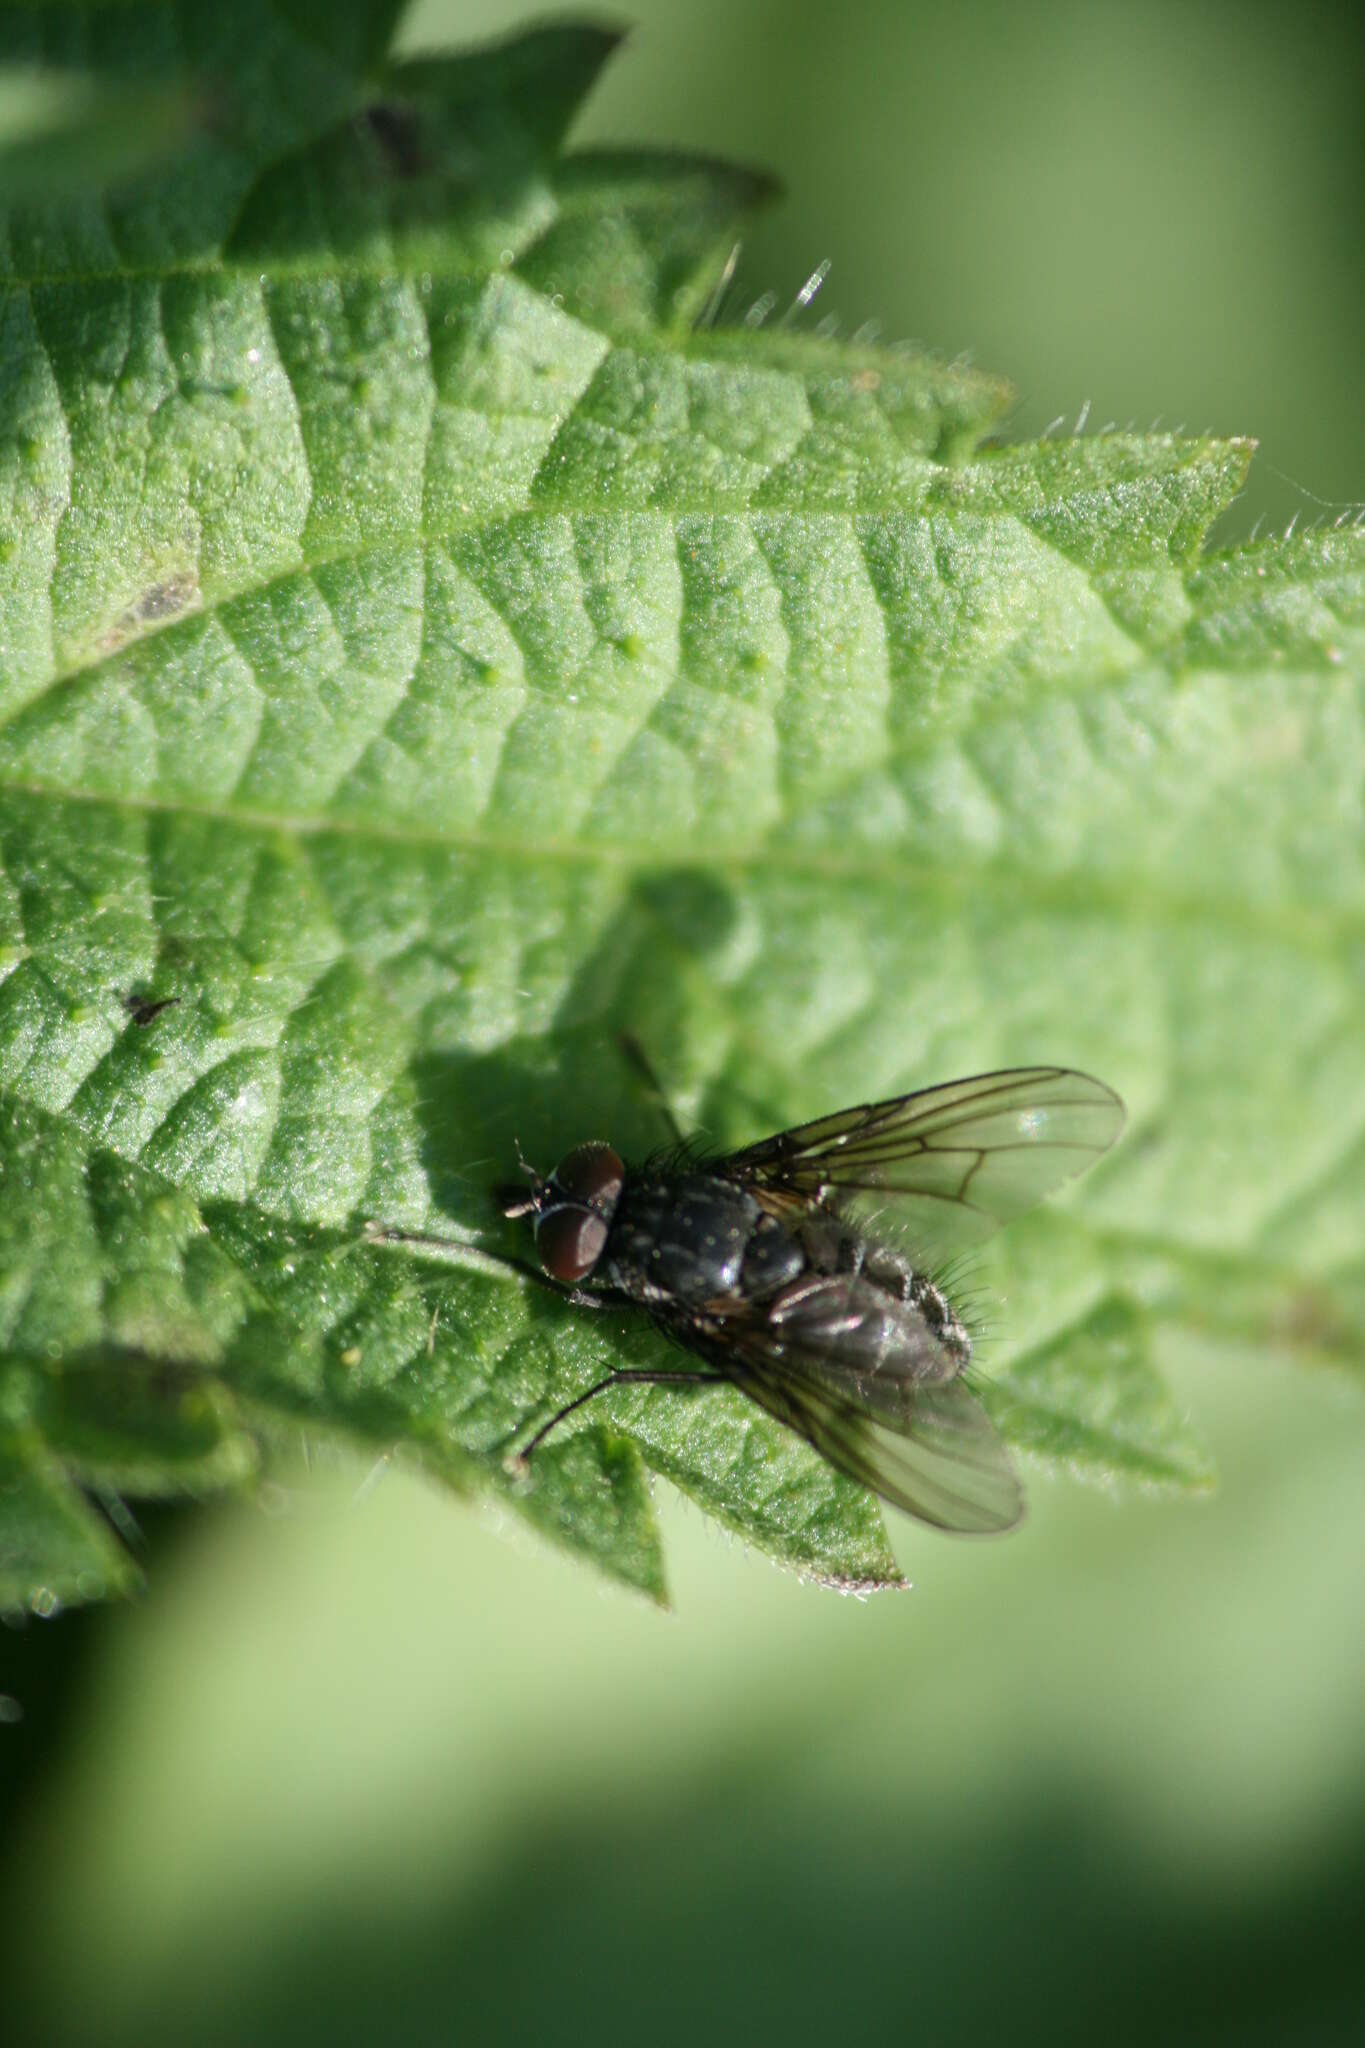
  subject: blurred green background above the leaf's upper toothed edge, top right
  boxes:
[517,0,1365,537]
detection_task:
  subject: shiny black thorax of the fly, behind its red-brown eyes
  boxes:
[604,1174,806,1307]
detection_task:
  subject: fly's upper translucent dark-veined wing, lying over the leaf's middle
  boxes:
[712,1067,1124,1249]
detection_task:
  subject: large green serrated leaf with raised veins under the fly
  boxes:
[0,0,1365,1604]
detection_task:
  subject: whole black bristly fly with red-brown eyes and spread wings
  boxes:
[372,1040,1124,1534]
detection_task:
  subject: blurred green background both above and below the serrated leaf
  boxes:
[0,0,1365,2044]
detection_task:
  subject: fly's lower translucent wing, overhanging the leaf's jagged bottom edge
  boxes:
[686,1274,1023,1536]
